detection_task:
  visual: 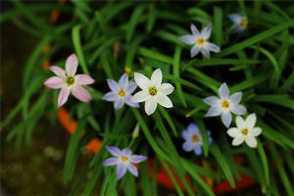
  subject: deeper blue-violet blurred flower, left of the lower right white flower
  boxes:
[182,123,212,155]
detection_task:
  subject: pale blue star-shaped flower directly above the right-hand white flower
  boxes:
[203,83,246,127]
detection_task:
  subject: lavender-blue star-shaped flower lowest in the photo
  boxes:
[103,146,147,179]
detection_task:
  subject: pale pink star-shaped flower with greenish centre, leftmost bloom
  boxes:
[44,54,94,107]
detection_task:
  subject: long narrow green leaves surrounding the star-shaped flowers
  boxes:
[0,0,294,196]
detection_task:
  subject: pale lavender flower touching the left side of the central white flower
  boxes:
[103,74,139,110]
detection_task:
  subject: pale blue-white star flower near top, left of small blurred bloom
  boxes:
[180,24,220,58]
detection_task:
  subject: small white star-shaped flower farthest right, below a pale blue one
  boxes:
[227,113,262,148]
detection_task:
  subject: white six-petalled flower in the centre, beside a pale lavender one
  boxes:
[133,69,174,115]
